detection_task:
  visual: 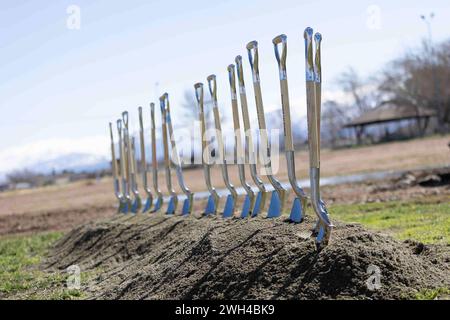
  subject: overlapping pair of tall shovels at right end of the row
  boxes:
[304,27,333,247]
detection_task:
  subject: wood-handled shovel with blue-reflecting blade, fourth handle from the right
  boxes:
[247,41,286,218]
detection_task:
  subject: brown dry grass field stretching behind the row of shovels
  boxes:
[0,135,450,235]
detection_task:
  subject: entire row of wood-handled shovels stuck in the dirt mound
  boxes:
[109,27,333,246]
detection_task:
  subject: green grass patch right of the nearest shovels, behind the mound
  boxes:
[330,201,450,244]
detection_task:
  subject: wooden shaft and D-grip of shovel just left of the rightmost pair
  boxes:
[272,34,294,151]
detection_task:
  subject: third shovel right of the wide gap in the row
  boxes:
[228,64,255,218]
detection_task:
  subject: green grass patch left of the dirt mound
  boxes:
[0,232,87,300]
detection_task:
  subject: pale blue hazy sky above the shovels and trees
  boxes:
[0,0,450,172]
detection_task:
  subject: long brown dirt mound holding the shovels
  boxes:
[44,214,450,299]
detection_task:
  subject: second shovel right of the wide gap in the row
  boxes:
[207,74,237,218]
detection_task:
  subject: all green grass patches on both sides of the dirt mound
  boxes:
[0,198,450,299]
